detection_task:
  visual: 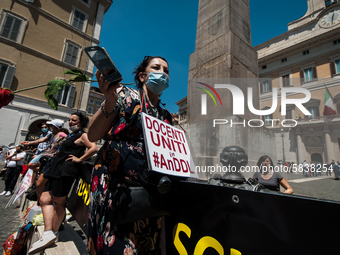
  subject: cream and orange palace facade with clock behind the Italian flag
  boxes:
[254,0,340,163]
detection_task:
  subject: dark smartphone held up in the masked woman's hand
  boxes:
[84,46,123,85]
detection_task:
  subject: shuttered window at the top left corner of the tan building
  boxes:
[0,9,27,43]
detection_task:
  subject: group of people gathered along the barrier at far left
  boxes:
[0,112,98,254]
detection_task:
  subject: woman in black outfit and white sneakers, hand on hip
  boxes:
[28,112,98,254]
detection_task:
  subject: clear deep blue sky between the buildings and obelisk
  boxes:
[95,0,307,112]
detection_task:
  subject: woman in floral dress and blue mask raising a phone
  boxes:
[88,56,172,255]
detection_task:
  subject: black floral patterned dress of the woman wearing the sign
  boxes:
[88,87,172,255]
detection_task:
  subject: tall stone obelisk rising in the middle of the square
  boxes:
[188,0,275,177]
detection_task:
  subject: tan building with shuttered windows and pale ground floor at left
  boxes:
[0,0,112,145]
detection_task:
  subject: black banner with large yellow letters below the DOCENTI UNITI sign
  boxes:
[165,182,340,255]
